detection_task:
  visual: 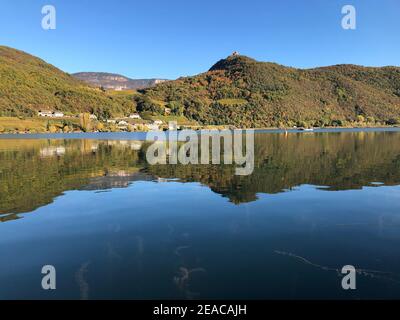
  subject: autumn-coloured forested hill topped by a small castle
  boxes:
[138,55,400,127]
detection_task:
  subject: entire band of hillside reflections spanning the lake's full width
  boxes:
[0,132,400,221]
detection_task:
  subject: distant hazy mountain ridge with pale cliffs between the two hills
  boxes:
[72,72,167,90]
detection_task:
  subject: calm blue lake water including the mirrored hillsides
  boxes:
[0,130,400,299]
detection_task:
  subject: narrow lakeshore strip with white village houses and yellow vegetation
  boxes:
[0,108,398,134]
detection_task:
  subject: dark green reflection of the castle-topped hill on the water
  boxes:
[148,132,400,203]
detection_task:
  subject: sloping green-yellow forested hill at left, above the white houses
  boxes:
[0,46,135,116]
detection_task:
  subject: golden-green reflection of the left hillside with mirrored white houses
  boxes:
[0,140,148,214]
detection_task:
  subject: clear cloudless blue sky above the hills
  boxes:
[0,0,400,79]
